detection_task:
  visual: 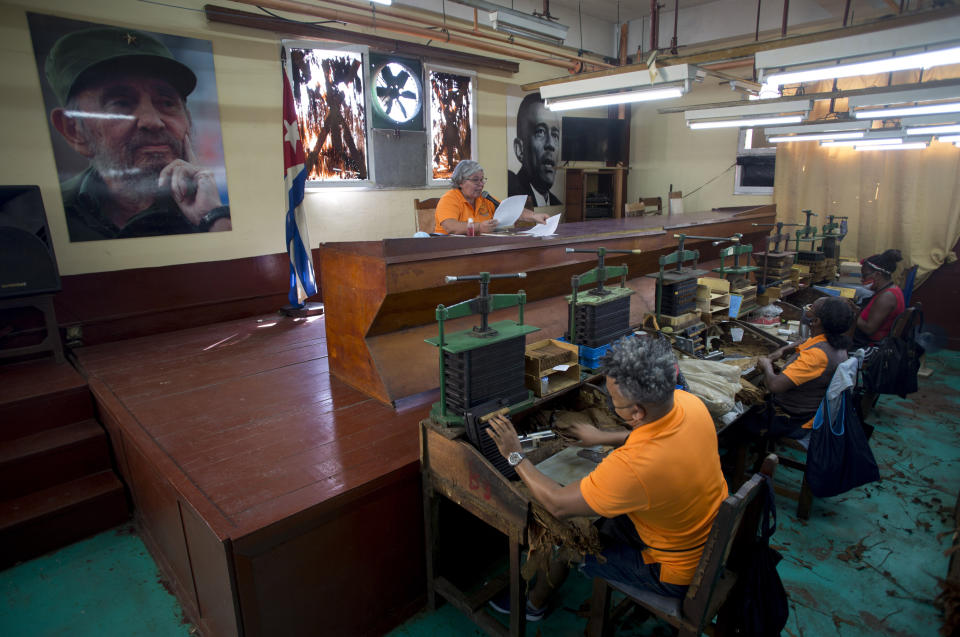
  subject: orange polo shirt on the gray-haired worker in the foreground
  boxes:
[580,389,728,585]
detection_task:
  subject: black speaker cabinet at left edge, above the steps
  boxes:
[0,186,60,299]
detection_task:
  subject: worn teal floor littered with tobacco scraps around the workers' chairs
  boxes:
[390,352,960,637]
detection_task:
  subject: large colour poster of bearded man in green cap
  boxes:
[28,14,232,241]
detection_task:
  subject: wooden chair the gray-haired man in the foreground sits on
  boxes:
[587,454,777,637]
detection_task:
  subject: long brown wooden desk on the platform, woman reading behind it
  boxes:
[320,205,776,403]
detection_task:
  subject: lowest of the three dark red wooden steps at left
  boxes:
[0,471,129,569]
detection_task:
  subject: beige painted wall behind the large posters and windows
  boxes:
[0,0,771,275]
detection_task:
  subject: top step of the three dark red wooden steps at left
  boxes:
[0,360,93,441]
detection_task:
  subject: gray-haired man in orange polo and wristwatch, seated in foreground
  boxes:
[490,336,728,619]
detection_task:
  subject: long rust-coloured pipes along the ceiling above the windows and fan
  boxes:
[225,0,613,73]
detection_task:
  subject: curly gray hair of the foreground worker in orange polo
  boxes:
[600,335,678,404]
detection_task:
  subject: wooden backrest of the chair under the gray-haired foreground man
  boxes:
[683,454,779,634]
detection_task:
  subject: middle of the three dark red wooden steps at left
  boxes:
[0,419,110,500]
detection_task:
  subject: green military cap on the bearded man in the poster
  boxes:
[45,27,197,104]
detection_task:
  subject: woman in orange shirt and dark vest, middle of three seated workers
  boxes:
[747,296,856,438]
